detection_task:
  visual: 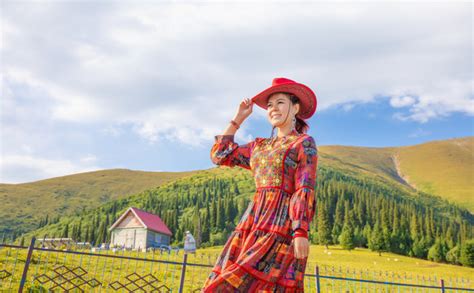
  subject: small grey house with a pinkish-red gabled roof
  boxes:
[109,207,173,249]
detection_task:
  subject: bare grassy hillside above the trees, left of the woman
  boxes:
[0,169,195,234]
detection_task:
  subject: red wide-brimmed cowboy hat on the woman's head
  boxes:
[252,77,317,119]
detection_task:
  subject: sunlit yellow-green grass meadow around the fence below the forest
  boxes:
[0,246,474,292]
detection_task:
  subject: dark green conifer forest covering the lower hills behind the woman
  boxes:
[23,168,474,266]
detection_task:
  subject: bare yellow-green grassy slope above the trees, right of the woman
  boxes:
[318,137,474,213]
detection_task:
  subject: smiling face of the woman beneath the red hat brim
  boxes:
[267,93,299,127]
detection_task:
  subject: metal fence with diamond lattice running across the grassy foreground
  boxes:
[0,238,474,293]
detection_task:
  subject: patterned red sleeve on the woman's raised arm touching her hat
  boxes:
[211,135,256,170]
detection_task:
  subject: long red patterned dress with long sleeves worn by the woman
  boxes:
[202,130,318,293]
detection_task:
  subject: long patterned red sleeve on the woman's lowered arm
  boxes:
[289,136,318,237]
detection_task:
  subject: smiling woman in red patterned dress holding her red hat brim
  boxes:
[202,78,318,292]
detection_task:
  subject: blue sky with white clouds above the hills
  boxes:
[0,0,474,183]
